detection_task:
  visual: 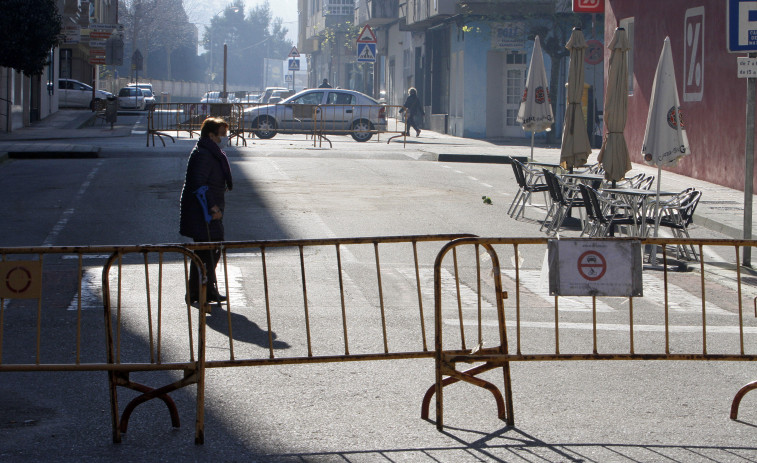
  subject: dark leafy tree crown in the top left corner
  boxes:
[0,0,61,75]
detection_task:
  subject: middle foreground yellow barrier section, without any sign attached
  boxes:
[179,234,472,368]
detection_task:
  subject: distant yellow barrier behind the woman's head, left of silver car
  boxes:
[147,103,250,146]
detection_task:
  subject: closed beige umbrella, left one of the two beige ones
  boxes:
[560,27,591,169]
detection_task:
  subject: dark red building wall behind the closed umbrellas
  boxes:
[604,0,757,191]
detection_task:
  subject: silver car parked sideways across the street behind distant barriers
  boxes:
[244,88,386,142]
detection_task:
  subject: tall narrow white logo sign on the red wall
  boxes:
[683,6,704,101]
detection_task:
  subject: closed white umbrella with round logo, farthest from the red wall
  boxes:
[516,35,555,161]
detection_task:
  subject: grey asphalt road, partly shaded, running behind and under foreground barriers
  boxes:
[0,125,757,462]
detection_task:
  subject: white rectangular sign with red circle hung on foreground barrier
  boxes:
[549,239,643,297]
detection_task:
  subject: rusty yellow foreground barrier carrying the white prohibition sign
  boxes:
[421,238,757,430]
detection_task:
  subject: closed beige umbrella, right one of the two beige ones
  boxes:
[597,27,631,182]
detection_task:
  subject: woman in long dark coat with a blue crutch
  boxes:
[179,118,232,303]
